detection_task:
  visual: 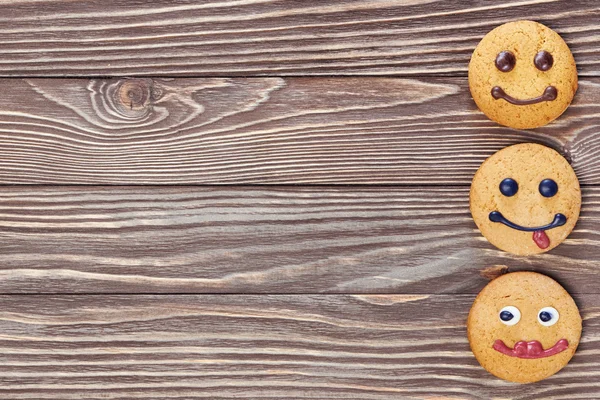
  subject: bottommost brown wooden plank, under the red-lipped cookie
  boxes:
[0,294,600,400]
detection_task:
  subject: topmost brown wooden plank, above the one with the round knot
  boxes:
[0,0,600,77]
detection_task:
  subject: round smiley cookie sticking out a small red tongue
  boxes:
[470,143,581,255]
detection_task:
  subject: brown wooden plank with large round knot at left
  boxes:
[0,78,600,185]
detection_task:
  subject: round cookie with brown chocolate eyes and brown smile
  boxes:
[469,21,577,129]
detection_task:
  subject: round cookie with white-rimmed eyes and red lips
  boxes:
[467,272,581,383]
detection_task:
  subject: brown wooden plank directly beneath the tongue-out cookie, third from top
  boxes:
[0,186,600,294]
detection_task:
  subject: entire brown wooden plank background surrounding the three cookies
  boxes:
[0,0,600,400]
